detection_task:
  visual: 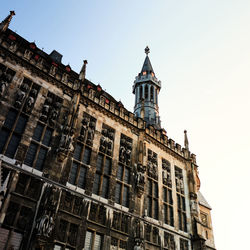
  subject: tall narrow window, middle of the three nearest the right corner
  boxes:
[162,159,174,226]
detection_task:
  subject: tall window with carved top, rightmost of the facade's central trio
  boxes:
[115,134,132,207]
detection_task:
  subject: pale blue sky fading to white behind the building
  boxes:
[0,0,250,250]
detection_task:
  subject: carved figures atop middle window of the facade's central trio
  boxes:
[99,127,114,155]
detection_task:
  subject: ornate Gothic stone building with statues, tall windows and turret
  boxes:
[0,11,215,250]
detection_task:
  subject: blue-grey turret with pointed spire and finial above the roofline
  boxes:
[133,47,161,129]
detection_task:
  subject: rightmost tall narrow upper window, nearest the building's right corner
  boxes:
[175,167,187,232]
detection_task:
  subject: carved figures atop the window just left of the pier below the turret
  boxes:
[119,134,132,165]
